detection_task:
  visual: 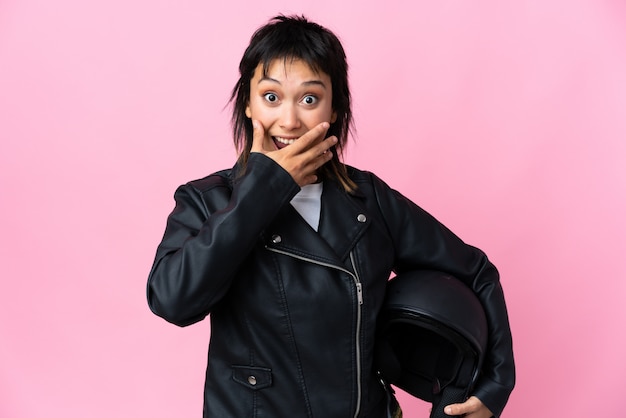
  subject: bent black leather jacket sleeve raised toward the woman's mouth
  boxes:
[147,153,300,326]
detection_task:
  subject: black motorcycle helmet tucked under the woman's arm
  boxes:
[376,270,487,418]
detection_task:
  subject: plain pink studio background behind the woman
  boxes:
[0,0,626,418]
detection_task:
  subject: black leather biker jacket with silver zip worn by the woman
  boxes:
[148,154,515,418]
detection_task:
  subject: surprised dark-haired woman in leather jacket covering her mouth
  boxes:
[148,16,515,418]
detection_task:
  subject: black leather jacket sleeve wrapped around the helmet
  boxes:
[372,175,515,417]
